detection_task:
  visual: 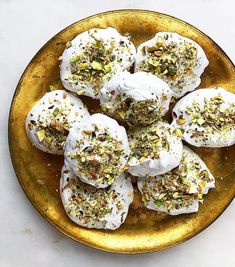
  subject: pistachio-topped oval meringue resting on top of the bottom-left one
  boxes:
[64,114,130,188]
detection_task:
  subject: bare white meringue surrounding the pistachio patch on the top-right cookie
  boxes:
[135,32,209,98]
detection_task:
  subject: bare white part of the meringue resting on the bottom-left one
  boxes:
[64,113,130,188]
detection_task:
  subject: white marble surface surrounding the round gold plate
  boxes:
[0,0,235,267]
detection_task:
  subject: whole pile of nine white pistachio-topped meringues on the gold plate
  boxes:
[26,28,235,230]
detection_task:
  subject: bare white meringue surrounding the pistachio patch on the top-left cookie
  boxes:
[60,27,136,98]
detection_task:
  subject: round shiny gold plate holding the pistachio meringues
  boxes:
[9,10,235,253]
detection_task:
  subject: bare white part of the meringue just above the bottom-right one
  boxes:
[128,122,183,176]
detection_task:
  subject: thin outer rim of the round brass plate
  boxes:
[8,9,235,254]
